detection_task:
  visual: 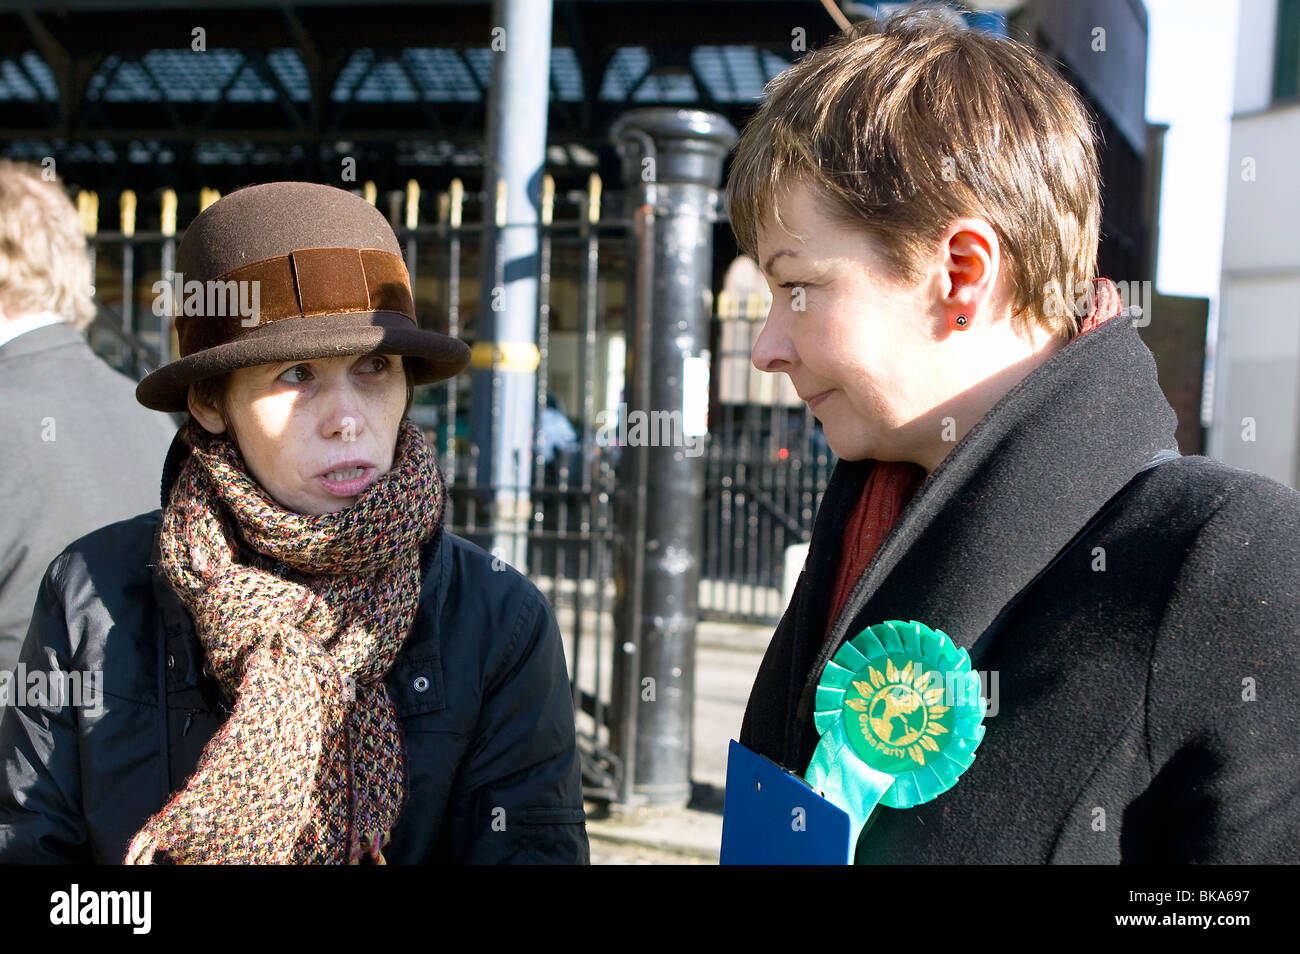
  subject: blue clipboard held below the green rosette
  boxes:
[719,740,854,864]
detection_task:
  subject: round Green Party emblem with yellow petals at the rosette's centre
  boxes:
[844,655,952,771]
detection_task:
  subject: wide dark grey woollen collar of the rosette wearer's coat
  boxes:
[785,316,1178,766]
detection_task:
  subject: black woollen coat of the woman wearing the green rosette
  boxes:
[741,317,1300,863]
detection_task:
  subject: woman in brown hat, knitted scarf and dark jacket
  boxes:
[0,182,588,863]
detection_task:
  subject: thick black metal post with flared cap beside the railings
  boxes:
[612,108,736,805]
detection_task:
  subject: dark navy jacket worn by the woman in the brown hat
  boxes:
[0,434,589,864]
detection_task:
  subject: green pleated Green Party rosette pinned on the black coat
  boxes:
[803,620,988,845]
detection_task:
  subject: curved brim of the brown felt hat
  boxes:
[135,312,469,411]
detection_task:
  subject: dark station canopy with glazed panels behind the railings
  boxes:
[0,0,837,190]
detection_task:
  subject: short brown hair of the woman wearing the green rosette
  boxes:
[727,5,1101,338]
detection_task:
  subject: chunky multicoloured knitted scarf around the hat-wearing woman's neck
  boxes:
[126,420,443,864]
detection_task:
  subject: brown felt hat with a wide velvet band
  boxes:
[135,182,469,411]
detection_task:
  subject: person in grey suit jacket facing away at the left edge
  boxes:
[0,160,176,710]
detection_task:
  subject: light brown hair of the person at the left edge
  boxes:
[0,159,95,330]
